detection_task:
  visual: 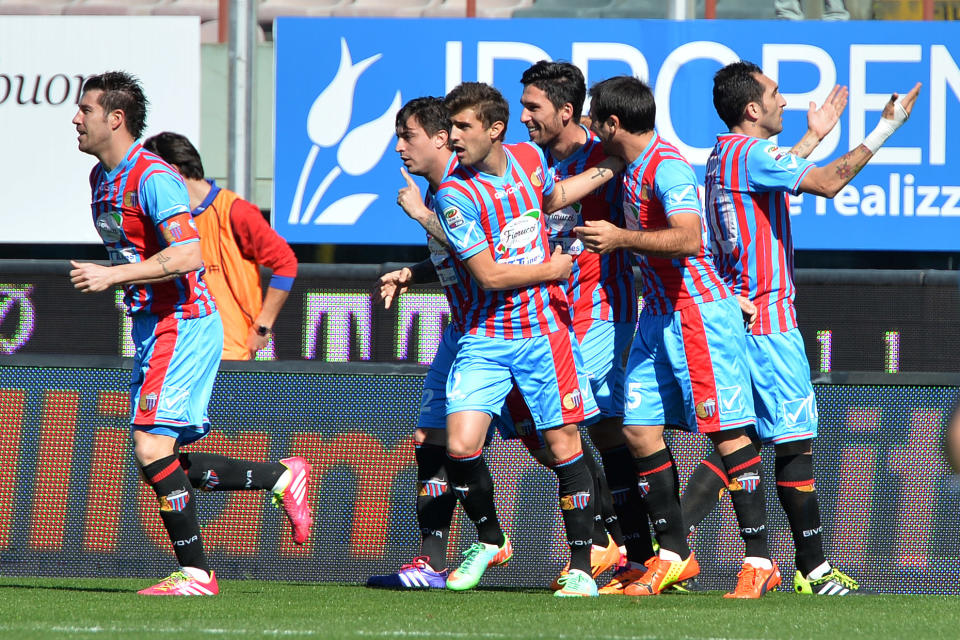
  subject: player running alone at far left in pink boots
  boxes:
[70,71,312,596]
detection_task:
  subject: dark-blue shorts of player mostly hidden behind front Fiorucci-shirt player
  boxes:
[417,324,542,448]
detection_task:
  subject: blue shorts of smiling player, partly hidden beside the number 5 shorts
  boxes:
[573,318,637,418]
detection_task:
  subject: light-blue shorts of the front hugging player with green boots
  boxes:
[447,329,599,429]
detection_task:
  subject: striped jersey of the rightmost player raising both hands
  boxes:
[705,133,815,335]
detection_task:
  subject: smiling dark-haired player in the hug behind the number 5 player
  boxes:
[520,60,654,594]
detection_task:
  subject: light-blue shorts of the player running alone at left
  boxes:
[130,313,223,444]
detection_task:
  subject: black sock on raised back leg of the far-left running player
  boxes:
[180,451,287,491]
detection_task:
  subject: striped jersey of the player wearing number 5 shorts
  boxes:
[623,134,730,314]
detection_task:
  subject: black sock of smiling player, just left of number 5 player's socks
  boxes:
[600,446,655,564]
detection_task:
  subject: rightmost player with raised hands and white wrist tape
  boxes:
[688,61,920,595]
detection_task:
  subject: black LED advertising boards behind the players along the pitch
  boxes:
[0,261,960,594]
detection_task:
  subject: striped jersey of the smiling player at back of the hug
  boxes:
[545,125,637,322]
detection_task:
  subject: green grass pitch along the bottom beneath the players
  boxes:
[0,577,960,640]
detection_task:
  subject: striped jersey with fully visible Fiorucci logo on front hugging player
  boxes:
[435,142,570,340]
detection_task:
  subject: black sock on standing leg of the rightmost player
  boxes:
[777,453,827,576]
